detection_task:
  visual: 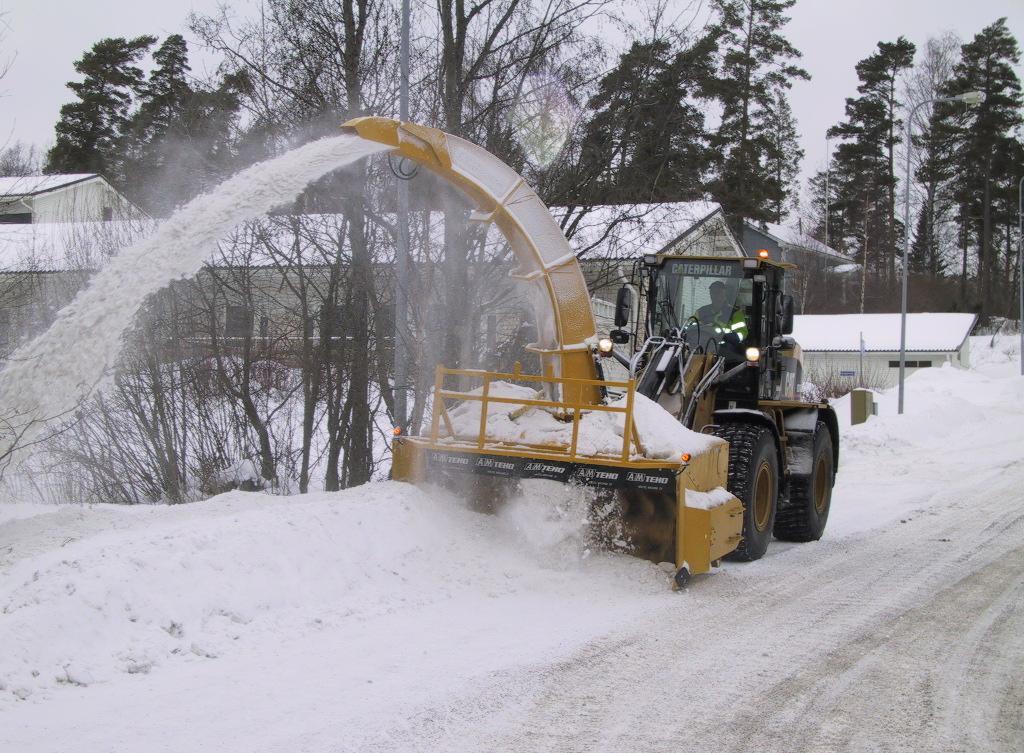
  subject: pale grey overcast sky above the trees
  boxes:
[0,0,1024,197]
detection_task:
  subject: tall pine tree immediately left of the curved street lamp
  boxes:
[828,37,914,297]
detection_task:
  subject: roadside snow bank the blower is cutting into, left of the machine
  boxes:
[0,483,664,707]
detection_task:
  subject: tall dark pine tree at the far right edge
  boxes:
[934,18,1022,312]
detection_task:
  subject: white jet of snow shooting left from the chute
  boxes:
[0,134,388,458]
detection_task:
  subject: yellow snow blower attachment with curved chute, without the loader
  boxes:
[343,118,742,574]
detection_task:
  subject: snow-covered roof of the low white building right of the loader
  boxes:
[793,313,978,352]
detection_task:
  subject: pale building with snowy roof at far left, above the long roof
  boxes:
[0,173,137,224]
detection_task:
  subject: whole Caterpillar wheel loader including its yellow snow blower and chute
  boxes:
[342,117,839,587]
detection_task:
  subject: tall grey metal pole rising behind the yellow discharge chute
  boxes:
[394,0,410,433]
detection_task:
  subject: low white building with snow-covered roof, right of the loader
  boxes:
[793,313,978,388]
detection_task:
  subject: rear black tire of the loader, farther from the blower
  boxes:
[775,421,835,542]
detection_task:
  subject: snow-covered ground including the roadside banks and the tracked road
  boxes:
[0,338,1024,753]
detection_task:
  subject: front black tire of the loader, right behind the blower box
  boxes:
[715,422,778,561]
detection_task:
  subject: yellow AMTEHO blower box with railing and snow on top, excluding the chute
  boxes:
[392,366,743,585]
